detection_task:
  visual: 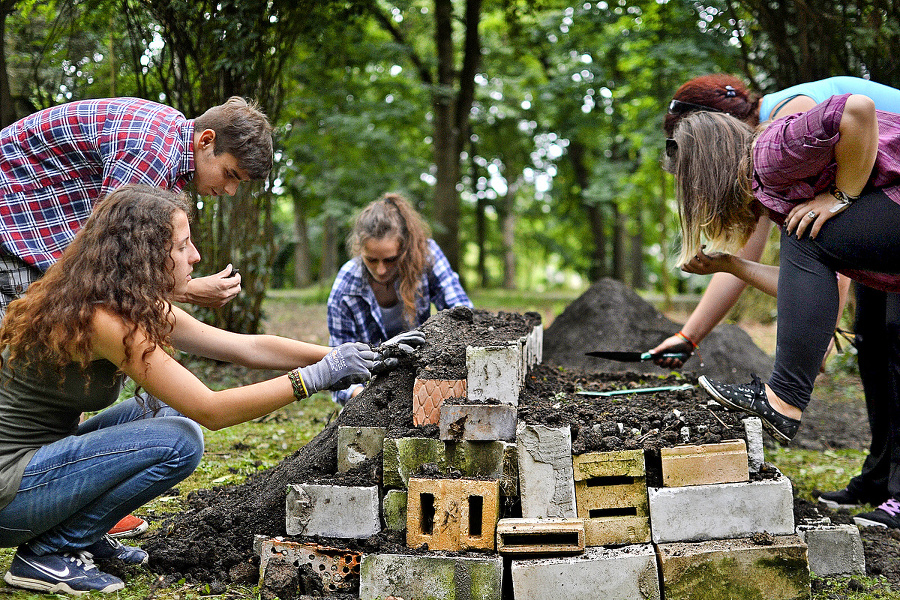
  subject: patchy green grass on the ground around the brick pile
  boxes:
[0,288,888,600]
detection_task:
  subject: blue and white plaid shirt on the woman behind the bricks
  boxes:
[328,239,472,404]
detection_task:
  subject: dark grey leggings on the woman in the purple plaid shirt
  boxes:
[769,190,900,410]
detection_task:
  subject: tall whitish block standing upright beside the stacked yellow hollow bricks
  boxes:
[516,422,577,519]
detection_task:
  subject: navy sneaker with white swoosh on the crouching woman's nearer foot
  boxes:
[3,546,125,596]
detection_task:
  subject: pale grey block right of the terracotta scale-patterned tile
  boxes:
[466,344,525,406]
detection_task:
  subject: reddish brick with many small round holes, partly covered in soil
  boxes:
[259,538,362,592]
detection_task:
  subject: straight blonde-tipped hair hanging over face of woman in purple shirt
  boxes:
[664,112,762,265]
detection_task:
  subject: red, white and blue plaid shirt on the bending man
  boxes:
[0,98,194,271]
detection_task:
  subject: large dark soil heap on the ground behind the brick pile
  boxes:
[544,278,772,383]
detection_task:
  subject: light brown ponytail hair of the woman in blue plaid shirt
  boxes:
[347,194,434,327]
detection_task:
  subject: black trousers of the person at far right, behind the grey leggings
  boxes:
[847,285,900,504]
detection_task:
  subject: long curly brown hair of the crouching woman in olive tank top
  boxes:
[0,185,190,378]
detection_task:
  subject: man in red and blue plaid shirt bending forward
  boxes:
[0,97,272,318]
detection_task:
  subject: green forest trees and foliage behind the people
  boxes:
[0,0,900,332]
